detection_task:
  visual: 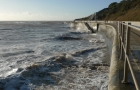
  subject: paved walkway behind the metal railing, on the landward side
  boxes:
[108,23,140,90]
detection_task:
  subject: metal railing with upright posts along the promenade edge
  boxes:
[118,22,140,90]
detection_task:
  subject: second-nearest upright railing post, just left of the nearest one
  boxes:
[120,22,125,60]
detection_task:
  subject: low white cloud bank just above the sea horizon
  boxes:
[0,12,69,21]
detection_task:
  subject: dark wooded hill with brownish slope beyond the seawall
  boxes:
[76,0,140,21]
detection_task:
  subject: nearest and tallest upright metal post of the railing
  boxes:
[122,23,131,84]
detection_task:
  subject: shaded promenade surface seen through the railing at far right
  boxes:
[120,22,140,90]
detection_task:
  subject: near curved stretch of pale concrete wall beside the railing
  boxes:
[99,25,120,90]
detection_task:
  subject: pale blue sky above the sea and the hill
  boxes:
[0,0,121,21]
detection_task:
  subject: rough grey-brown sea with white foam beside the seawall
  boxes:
[0,21,110,90]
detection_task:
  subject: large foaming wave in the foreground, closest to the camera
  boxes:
[0,53,108,90]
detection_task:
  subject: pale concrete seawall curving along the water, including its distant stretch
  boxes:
[74,22,120,90]
